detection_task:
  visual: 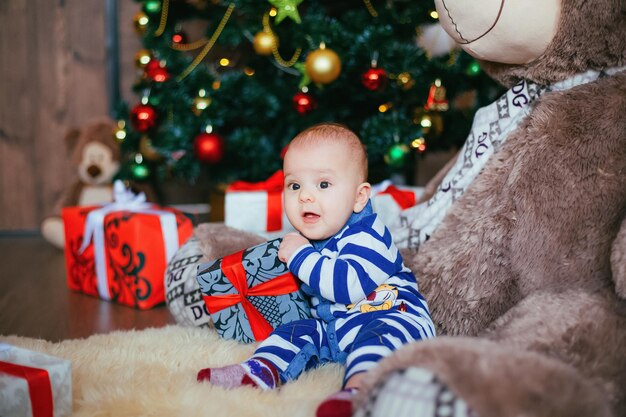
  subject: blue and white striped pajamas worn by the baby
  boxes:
[252,214,435,384]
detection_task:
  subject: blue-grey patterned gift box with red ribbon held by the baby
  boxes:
[197,239,311,343]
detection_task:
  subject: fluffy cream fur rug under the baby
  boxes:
[0,326,343,417]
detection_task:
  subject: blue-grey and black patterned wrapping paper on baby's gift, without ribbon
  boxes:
[197,239,312,343]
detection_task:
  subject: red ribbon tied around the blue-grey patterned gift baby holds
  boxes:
[203,251,298,341]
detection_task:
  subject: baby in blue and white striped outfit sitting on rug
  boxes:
[198,123,435,416]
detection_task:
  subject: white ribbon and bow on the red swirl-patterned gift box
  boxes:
[78,180,179,300]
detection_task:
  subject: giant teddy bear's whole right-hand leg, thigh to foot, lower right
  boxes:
[361,284,626,417]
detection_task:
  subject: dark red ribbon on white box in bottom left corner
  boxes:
[0,361,54,417]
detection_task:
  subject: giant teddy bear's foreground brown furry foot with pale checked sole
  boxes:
[355,336,613,417]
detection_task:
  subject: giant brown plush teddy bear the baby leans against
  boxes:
[193,0,626,417]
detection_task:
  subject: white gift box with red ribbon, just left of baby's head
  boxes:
[224,171,294,239]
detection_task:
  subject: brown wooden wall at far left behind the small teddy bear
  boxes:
[0,0,109,231]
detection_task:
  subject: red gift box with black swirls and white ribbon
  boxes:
[62,182,193,309]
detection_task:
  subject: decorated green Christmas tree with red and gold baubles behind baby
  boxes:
[116,0,499,187]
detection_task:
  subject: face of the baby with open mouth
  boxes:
[283,142,363,240]
